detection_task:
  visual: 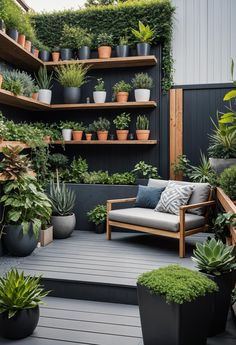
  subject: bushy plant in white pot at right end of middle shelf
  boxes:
[132,73,153,102]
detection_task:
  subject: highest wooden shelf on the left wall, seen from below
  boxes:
[0,31,44,72]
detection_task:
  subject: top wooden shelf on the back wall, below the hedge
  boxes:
[44,55,157,70]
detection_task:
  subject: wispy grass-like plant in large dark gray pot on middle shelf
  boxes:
[55,64,89,104]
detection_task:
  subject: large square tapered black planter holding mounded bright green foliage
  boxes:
[138,285,210,345]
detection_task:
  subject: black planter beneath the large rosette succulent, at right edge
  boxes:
[207,270,236,337]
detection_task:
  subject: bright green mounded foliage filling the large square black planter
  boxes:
[138,265,218,304]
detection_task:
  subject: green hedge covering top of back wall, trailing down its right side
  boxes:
[32,0,174,90]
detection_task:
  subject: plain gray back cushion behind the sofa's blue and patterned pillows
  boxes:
[148,178,210,216]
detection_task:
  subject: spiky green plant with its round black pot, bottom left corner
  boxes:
[0,269,49,339]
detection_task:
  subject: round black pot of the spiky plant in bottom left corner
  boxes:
[0,306,39,339]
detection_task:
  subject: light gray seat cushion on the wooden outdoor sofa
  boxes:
[109,207,205,232]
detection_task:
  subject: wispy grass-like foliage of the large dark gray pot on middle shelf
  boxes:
[55,63,89,87]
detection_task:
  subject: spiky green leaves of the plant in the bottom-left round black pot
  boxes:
[0,269,49,319]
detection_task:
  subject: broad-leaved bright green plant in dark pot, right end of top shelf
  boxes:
[132,21,155,56]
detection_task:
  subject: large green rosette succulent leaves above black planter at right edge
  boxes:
[192,238,236,276]
